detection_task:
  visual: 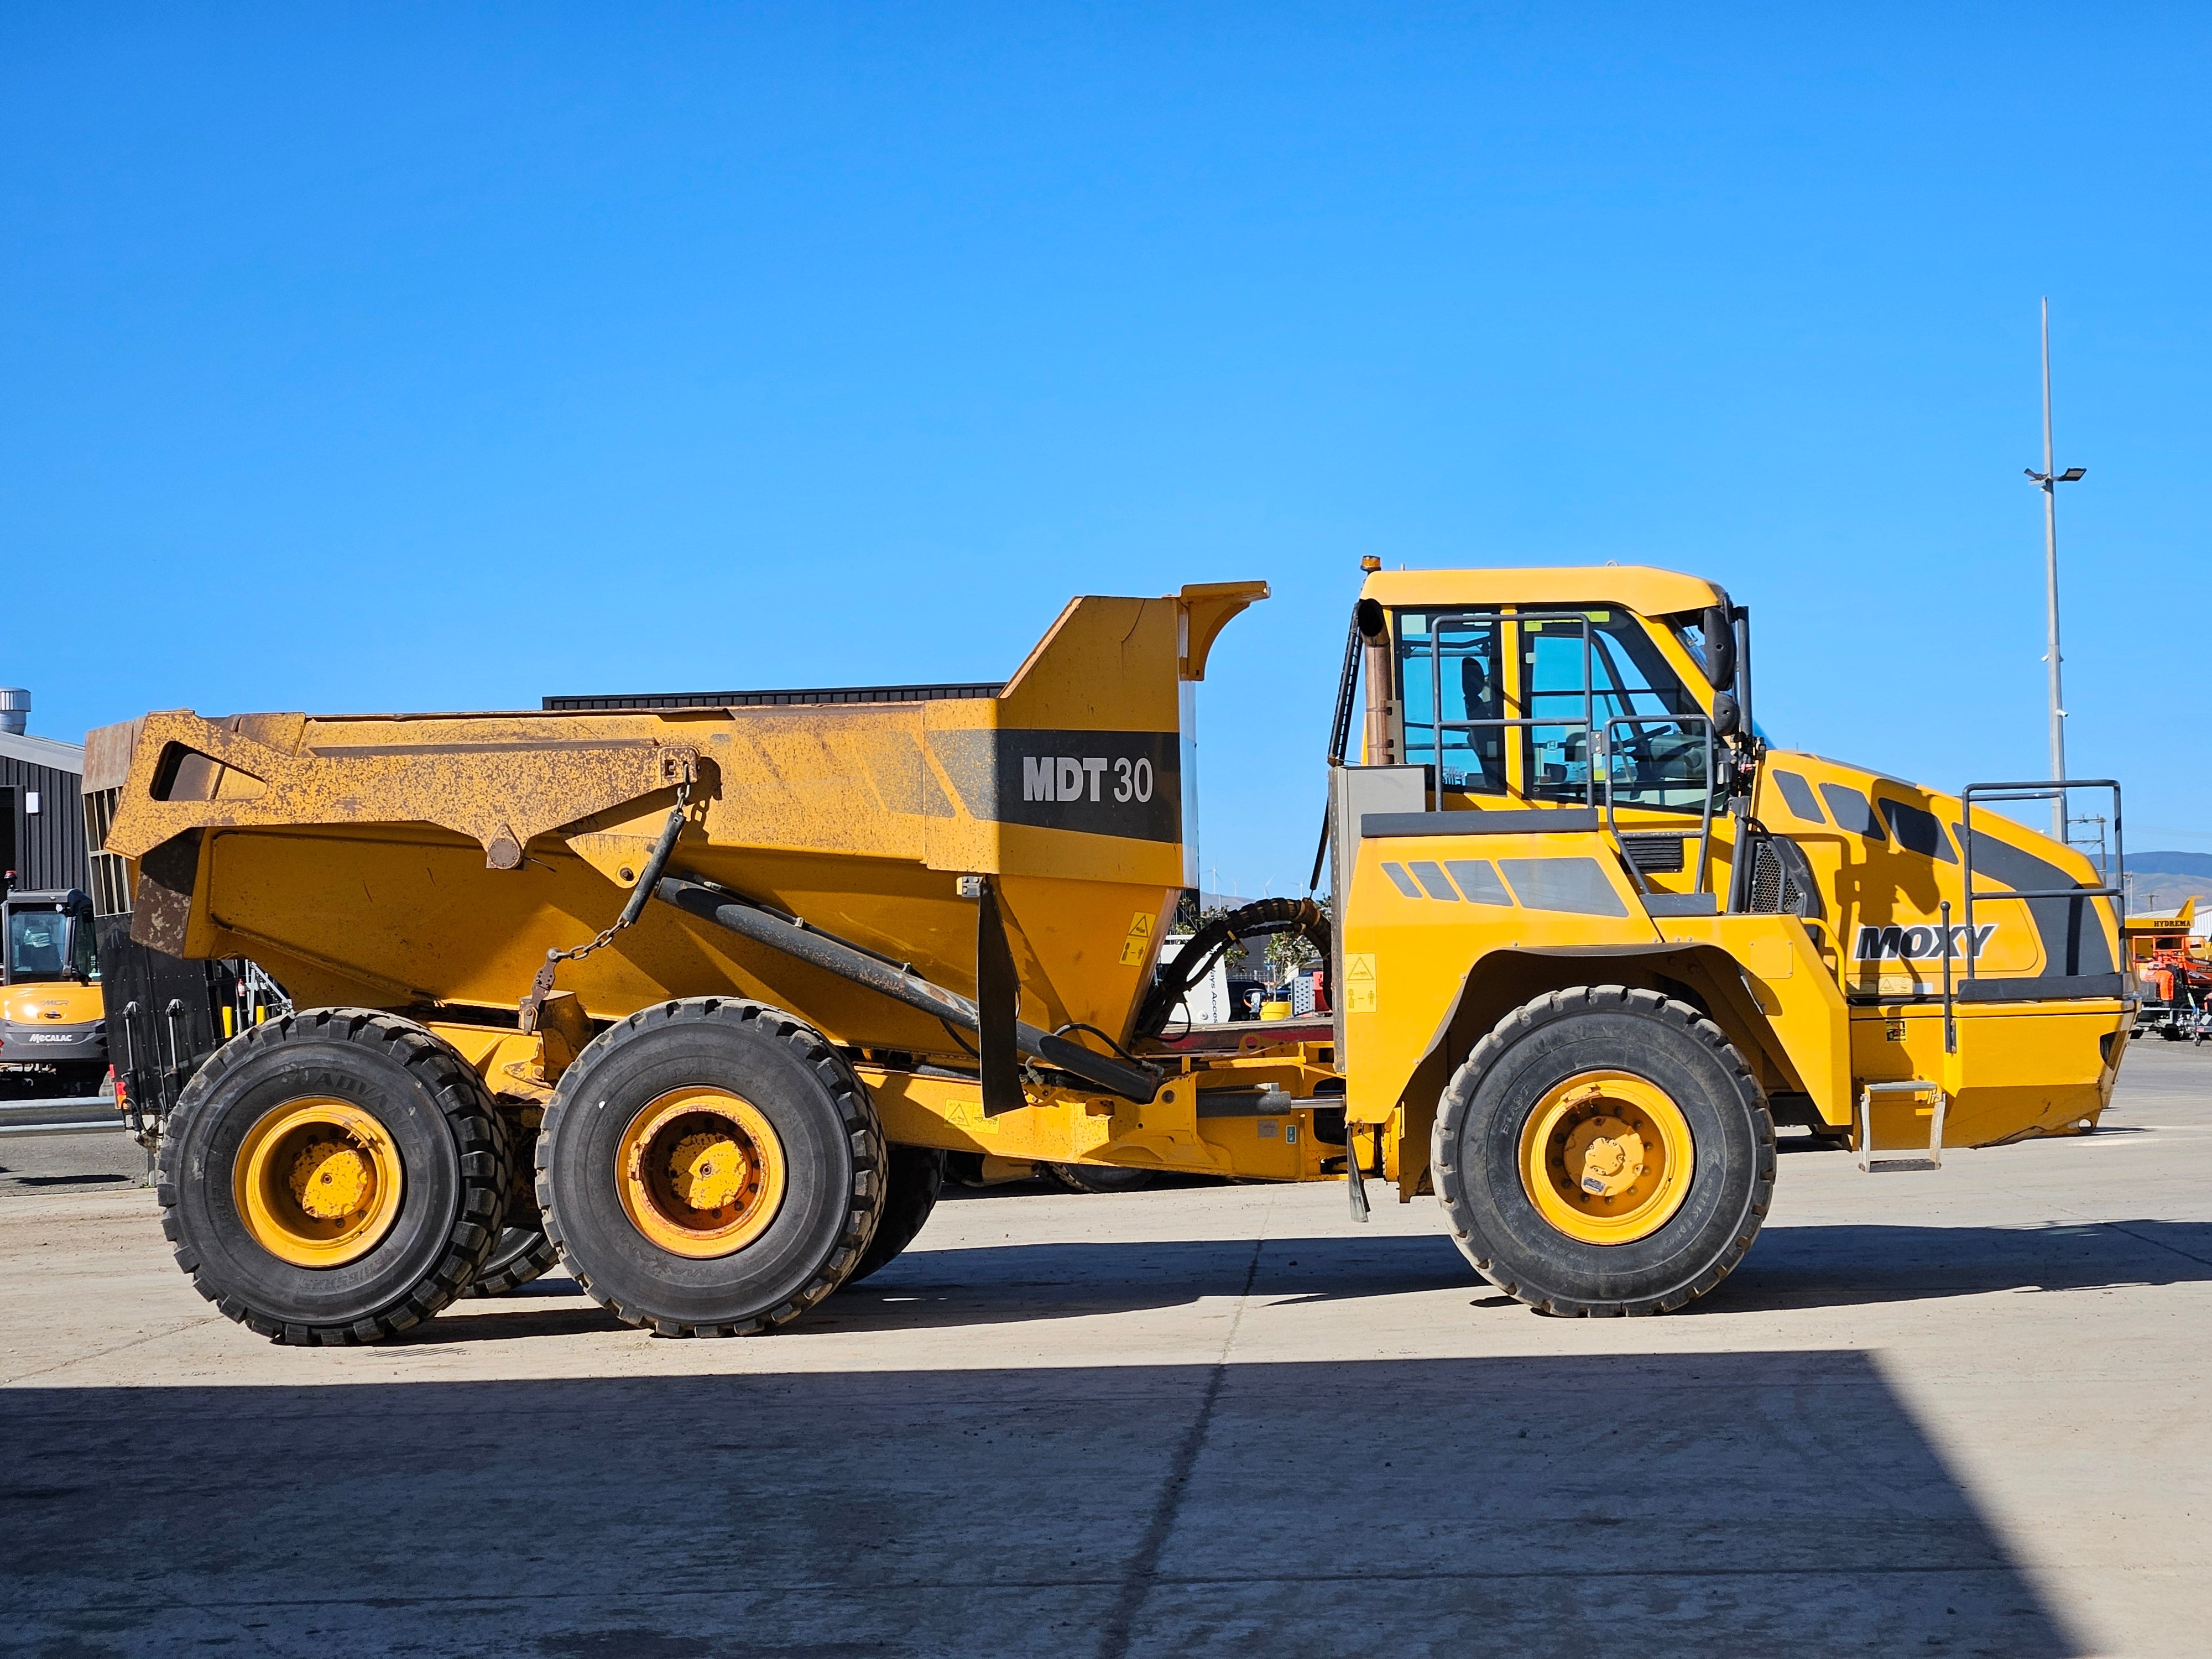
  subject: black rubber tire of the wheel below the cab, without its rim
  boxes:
[1429,984,1774,1316]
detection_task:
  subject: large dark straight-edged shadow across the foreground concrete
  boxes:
[0,1354,2086,1659]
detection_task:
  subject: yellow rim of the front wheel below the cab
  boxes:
[1520,1071,1697,1243]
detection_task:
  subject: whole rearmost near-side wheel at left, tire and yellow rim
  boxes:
[157,1009,509,1343]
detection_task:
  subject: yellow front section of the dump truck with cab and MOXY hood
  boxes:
[1329,564,2130,1303]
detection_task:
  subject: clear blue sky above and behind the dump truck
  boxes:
[0,4,2212,894]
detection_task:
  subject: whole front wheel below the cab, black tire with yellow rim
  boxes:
[1431,984,1774,1314]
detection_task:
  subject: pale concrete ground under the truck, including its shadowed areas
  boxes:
[0,1044,2212,1659]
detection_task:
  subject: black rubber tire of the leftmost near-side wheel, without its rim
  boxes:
[157,1009,511,1345]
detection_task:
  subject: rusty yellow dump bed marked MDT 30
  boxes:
[106,584,1265,1055]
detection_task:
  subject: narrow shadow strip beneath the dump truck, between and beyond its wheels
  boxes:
[411,1221,2212,1343]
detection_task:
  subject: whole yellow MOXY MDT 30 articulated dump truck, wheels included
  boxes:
[88,562,2130,1343]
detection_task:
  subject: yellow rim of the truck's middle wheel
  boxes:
[615,1088,790,1261]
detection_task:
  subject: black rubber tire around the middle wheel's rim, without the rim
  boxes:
[538,998,885,1336]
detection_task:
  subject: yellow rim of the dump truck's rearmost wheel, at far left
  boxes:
[230,1097,400,1267]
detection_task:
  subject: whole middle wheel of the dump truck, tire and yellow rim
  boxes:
[538,998,885,1336]
